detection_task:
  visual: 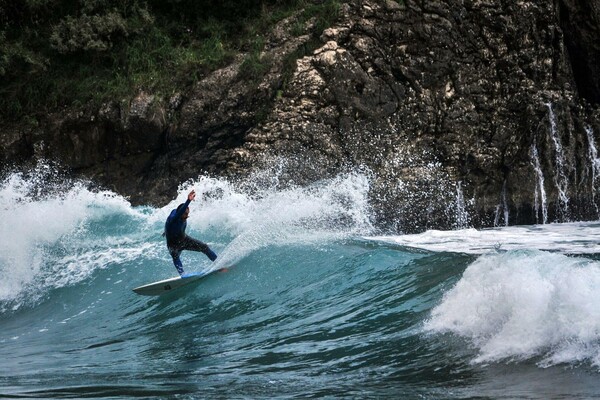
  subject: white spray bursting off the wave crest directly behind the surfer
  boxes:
[158,174,372,268]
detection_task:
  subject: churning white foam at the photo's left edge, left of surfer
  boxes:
[0,165,135,301]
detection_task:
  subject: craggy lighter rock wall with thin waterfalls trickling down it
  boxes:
[234,1,600,231]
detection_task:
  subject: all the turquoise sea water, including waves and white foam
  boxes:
[0,167,600,399]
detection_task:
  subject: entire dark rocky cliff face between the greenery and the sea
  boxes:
[2,0,600,231]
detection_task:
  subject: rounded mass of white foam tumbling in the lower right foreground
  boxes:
[425,251,600,367]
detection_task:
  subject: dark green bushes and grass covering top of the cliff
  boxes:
[0,0,339,121]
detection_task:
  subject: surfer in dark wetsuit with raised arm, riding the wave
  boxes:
[164,190,217,275]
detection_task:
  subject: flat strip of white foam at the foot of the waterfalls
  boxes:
[368,222,600,254]
